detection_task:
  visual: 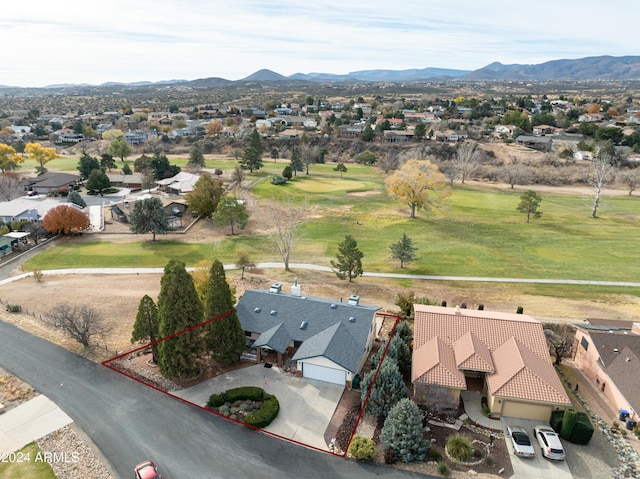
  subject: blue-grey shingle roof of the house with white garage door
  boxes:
[237,290,380,373]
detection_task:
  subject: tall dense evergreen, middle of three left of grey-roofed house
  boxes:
[158,260,203,379]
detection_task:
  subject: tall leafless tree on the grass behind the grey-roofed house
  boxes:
[265,198,306,271]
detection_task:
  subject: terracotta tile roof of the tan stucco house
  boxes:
[412,304,570,404]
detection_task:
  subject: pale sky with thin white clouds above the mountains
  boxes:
[0,0,640,87]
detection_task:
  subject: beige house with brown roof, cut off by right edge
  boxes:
[573,319,640,422]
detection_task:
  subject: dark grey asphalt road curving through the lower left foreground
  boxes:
[0,321,428,479]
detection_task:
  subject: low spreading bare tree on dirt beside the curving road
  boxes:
[45,303,109,347]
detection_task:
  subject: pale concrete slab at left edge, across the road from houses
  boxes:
[0,395,73,453]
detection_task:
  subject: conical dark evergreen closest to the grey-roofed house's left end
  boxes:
[204,260,246,365]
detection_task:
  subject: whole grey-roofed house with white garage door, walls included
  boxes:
[237,280,380,386]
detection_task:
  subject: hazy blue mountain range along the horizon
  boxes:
[0,55,640,88]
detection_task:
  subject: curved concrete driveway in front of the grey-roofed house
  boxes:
[173,364,344,451]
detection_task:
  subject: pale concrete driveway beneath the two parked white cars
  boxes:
[500,417,573,479]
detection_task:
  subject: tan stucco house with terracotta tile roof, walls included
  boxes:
[411,304,571,421]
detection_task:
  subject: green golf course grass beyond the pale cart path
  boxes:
[25,178,640,281]
